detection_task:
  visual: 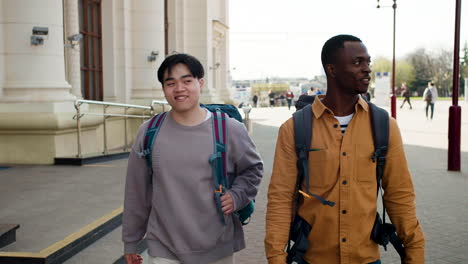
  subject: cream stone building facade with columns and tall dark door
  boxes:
[0,0,230,164]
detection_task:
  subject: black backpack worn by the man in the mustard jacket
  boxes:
[286,95,405,264]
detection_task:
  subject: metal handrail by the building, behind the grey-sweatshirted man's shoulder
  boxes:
[73,99,167,158]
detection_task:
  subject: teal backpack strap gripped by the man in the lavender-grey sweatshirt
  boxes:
[209,110,228,225]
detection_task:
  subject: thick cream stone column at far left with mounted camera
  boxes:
[0,0,76,103]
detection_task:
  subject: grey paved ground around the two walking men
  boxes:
[0,99,468,264]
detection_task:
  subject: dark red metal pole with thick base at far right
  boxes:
[448,0,466,171]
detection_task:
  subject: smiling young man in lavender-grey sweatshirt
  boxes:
[122,54,263,264]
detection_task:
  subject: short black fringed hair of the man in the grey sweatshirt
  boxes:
[158,53,205,84]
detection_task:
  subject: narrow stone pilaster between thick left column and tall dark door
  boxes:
[63,0,83,98]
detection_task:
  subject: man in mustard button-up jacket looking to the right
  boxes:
[265,35,425,264]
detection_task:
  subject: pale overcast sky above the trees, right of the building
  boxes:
[229,0,468,80]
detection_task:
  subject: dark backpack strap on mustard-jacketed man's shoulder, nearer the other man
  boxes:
[293,104,335,207]
